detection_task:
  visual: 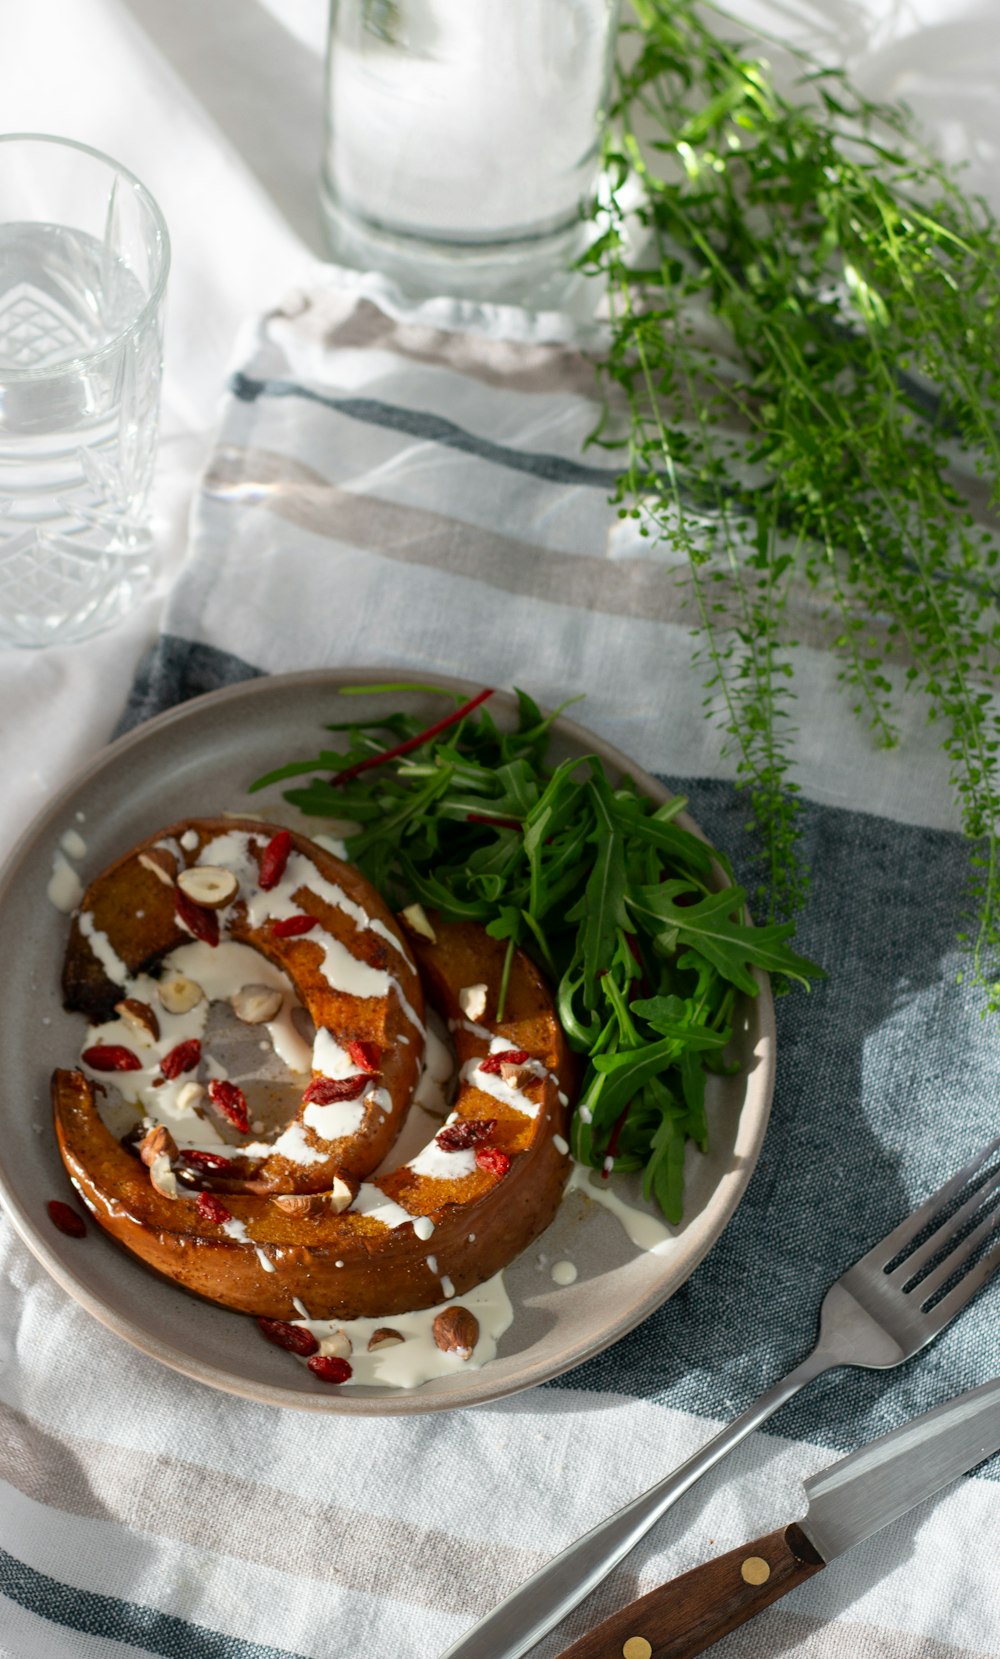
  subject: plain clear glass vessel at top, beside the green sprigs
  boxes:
[320,0,619,305]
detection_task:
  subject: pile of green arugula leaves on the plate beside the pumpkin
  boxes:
[252,684,823,1223]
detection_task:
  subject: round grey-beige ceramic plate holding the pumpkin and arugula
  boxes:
[0,669,774,1413]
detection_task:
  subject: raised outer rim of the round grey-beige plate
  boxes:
[0,664,776,1417]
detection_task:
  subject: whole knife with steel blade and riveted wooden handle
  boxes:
[550,1377,1000,1659]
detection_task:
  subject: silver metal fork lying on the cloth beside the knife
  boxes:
[443,1135,1000,1659]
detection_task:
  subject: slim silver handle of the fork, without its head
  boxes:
[443,1349,839,1659]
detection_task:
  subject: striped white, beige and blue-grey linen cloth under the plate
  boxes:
[0,274,1000,1659]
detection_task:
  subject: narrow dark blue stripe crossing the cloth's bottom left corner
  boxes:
[0,1550,308,1659]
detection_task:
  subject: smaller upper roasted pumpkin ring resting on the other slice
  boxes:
[63,820,423,1193]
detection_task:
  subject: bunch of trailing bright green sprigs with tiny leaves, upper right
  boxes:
[590,0,1000,1010]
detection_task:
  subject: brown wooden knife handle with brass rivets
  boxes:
[550,1521,826,1659]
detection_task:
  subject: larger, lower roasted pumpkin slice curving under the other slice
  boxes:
[53,825,572,1319]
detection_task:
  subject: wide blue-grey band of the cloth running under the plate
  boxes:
[115,637,1000,1480]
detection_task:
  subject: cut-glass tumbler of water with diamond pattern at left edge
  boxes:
[0,133,169,645]
